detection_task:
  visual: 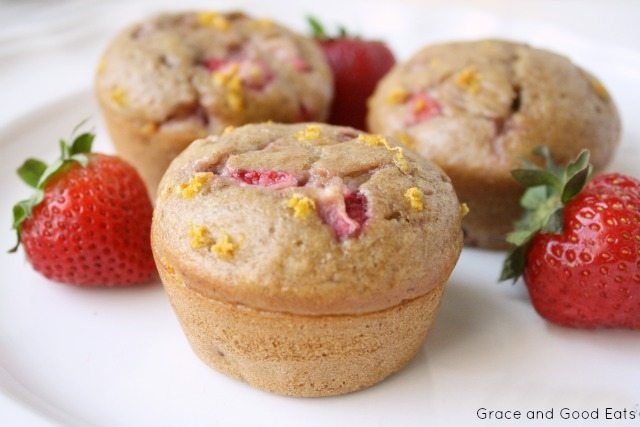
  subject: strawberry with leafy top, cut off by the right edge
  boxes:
[502,150,640,329]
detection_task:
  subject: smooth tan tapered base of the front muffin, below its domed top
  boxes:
[160,274,444,397]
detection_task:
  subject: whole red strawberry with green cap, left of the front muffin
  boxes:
[10,129,155,286]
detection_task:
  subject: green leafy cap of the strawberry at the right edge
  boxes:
[500,146,593,281]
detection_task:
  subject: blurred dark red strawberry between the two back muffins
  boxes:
[307,17,396,130]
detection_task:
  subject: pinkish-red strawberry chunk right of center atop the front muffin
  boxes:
[318,191,369,240]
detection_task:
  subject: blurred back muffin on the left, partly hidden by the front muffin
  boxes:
[95,12,333,198]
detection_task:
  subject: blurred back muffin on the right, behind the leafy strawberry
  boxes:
[368,40,620,248]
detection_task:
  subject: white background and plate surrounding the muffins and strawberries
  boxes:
[0,0,640,426]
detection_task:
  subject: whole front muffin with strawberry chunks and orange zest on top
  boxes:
[152,124,462,396]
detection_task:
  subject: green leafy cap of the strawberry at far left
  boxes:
[9,125,95,253]
